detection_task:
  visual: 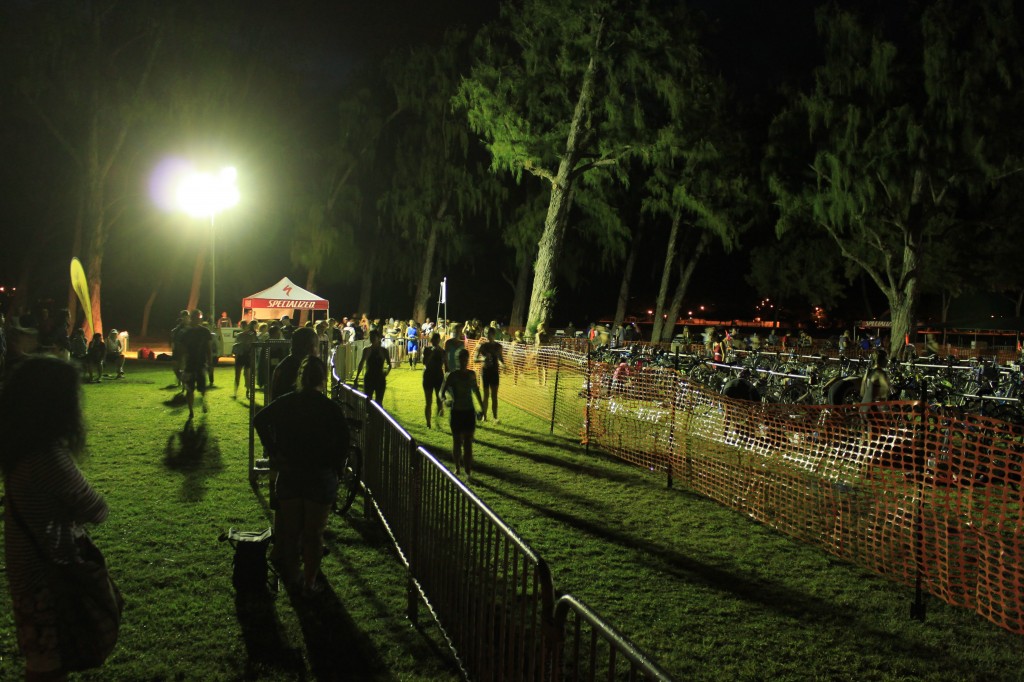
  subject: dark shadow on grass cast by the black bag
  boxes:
[234,593,306,680]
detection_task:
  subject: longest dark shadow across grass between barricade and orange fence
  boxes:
[476,482,956,666]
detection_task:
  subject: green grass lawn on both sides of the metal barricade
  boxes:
[0,364,1024,680]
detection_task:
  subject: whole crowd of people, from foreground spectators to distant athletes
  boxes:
[0,301,921,679]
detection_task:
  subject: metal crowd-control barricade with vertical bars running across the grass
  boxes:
[333,378,672,682]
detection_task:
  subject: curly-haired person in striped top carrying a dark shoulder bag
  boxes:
[0,356,124,680]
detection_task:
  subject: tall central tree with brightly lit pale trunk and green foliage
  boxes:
[456,0,699,328]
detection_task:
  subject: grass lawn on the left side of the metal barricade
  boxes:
[0,363,459,681]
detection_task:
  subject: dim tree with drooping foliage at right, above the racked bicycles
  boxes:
[769,0,1024,351]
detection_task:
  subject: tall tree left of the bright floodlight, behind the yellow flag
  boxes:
[4,0,162,331]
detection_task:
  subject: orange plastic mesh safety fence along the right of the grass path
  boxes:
[479,344,1024,634]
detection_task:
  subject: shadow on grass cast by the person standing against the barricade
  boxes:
[288,581,388,680]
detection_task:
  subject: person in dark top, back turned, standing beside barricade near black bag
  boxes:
[253,352,349,596]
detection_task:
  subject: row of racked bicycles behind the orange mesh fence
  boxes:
[590,345,1024,424]
